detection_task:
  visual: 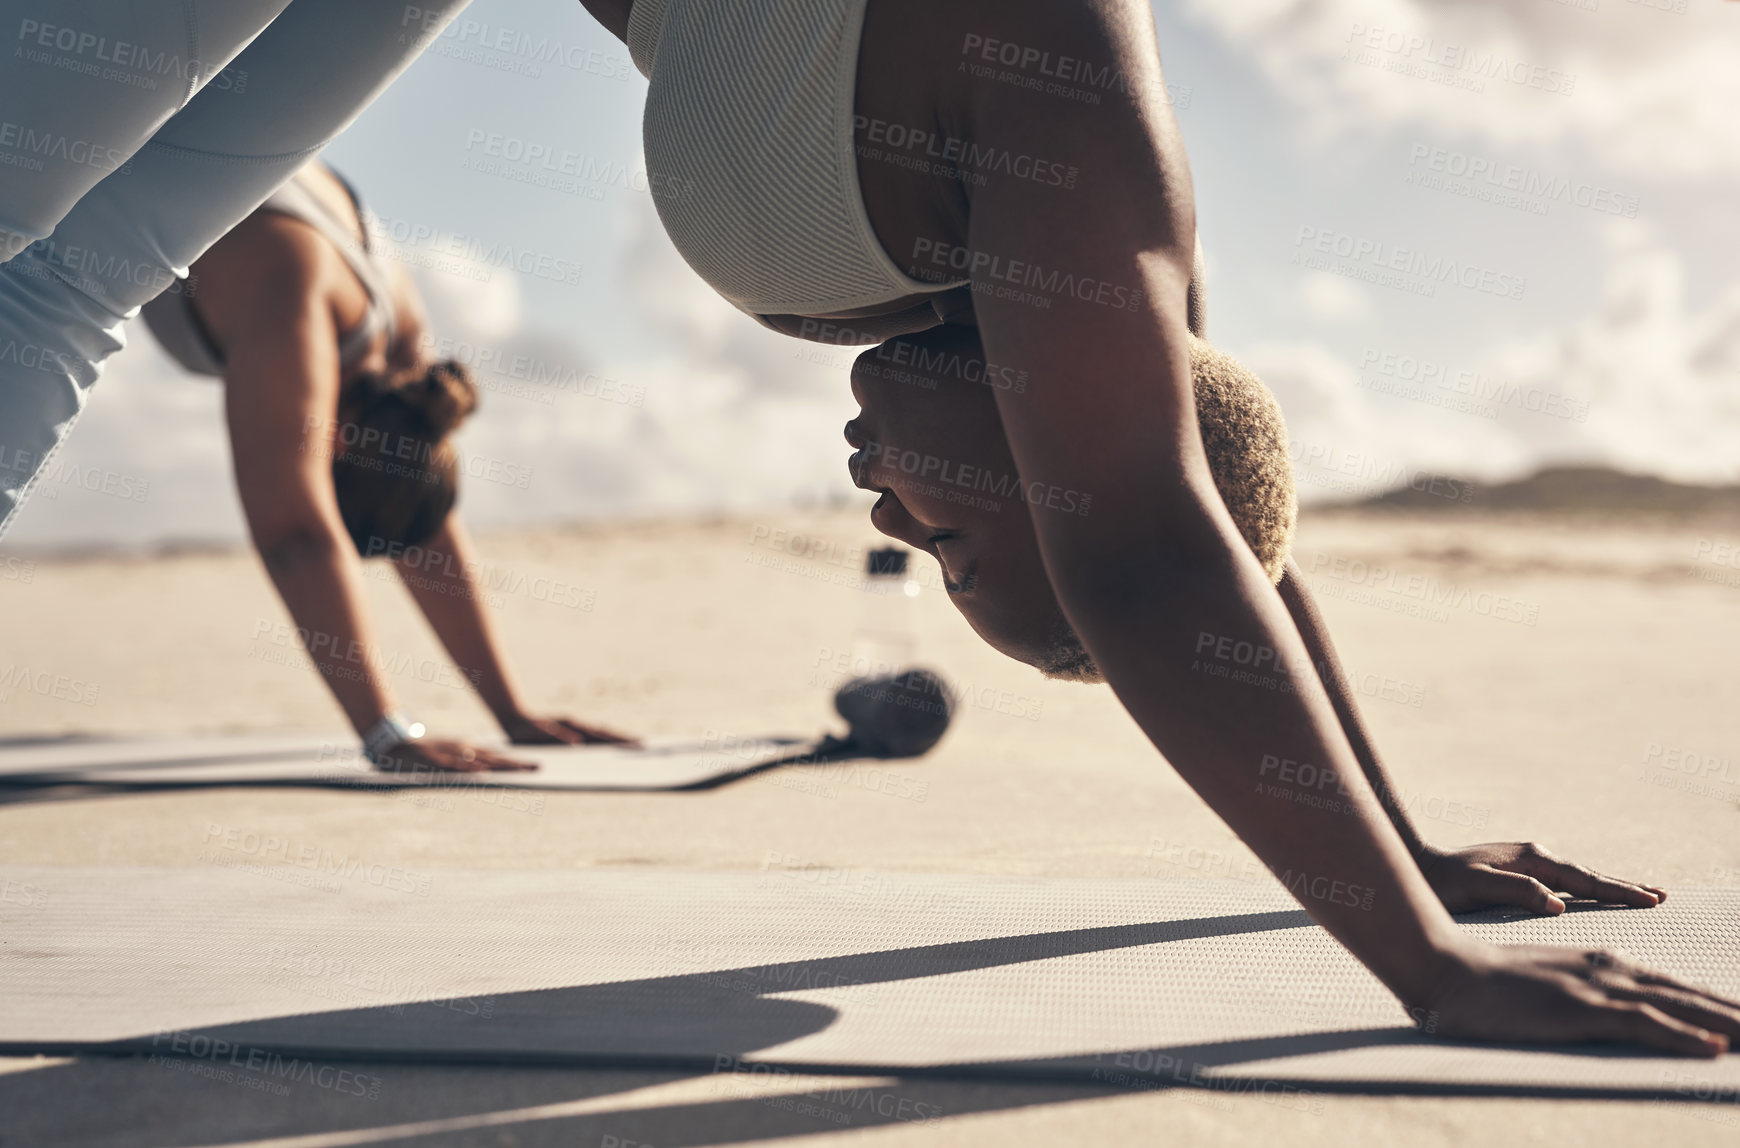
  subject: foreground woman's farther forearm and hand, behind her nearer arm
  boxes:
[1279,558,1667,915]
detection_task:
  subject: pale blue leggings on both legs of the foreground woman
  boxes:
[0,0,468,534]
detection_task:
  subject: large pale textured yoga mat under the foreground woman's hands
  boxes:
[0,866,1740,1101]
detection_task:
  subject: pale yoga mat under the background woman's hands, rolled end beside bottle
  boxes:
[0,734,814,790]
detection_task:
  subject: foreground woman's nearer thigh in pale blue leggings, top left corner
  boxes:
[0,0,289,261]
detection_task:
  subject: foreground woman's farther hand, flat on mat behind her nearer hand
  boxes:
[1420,842,1667,917]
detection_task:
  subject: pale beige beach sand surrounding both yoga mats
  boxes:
[0,511,1740,1148]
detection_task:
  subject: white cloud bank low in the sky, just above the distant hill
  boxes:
[1239,219,1740,501]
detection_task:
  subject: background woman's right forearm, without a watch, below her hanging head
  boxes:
[397,515,524,724]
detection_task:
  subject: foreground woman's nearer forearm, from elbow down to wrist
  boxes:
[1060,510,1465,1004]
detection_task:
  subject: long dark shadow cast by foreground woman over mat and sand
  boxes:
[0,910,1712,1148]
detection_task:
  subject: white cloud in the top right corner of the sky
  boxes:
[1187,0,1740,181]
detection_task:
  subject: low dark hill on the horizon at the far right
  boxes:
[1321,466,1740,518]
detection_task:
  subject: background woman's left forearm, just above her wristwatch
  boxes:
[259,527,395,736]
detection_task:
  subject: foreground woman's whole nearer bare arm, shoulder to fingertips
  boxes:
[967,0,1740,1054]
